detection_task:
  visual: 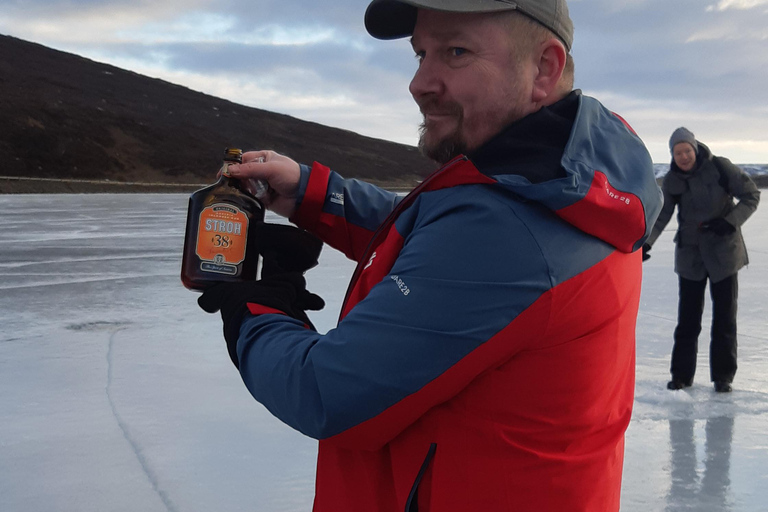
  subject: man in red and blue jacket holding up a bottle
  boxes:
[201,0,661,512]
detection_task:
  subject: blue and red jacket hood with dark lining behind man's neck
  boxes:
[469,91,662,252]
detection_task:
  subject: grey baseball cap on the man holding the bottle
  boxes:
[365,0,573,51]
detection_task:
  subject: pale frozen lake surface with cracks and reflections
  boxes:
[0,194,768,512]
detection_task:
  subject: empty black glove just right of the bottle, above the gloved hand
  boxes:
[255,223,323,278]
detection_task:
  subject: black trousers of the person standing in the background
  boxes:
[670,274,739,384]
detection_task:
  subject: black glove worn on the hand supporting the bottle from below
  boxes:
[197,272,325,368]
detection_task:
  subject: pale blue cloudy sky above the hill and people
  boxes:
[0,0,768,163]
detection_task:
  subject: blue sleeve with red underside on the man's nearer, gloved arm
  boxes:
[232,186,552,449]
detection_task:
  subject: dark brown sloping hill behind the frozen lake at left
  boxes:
[0,35,434,193]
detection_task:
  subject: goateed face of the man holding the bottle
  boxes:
[410,9,535,163]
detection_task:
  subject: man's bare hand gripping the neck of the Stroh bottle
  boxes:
[227,151,301,218]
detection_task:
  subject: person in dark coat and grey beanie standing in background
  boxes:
[643,127,760,393]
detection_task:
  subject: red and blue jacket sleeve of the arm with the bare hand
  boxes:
[290,162,402,261]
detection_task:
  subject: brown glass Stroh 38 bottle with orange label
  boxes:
[181,149,264,291]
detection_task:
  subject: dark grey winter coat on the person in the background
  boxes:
[646,142,760,283]
